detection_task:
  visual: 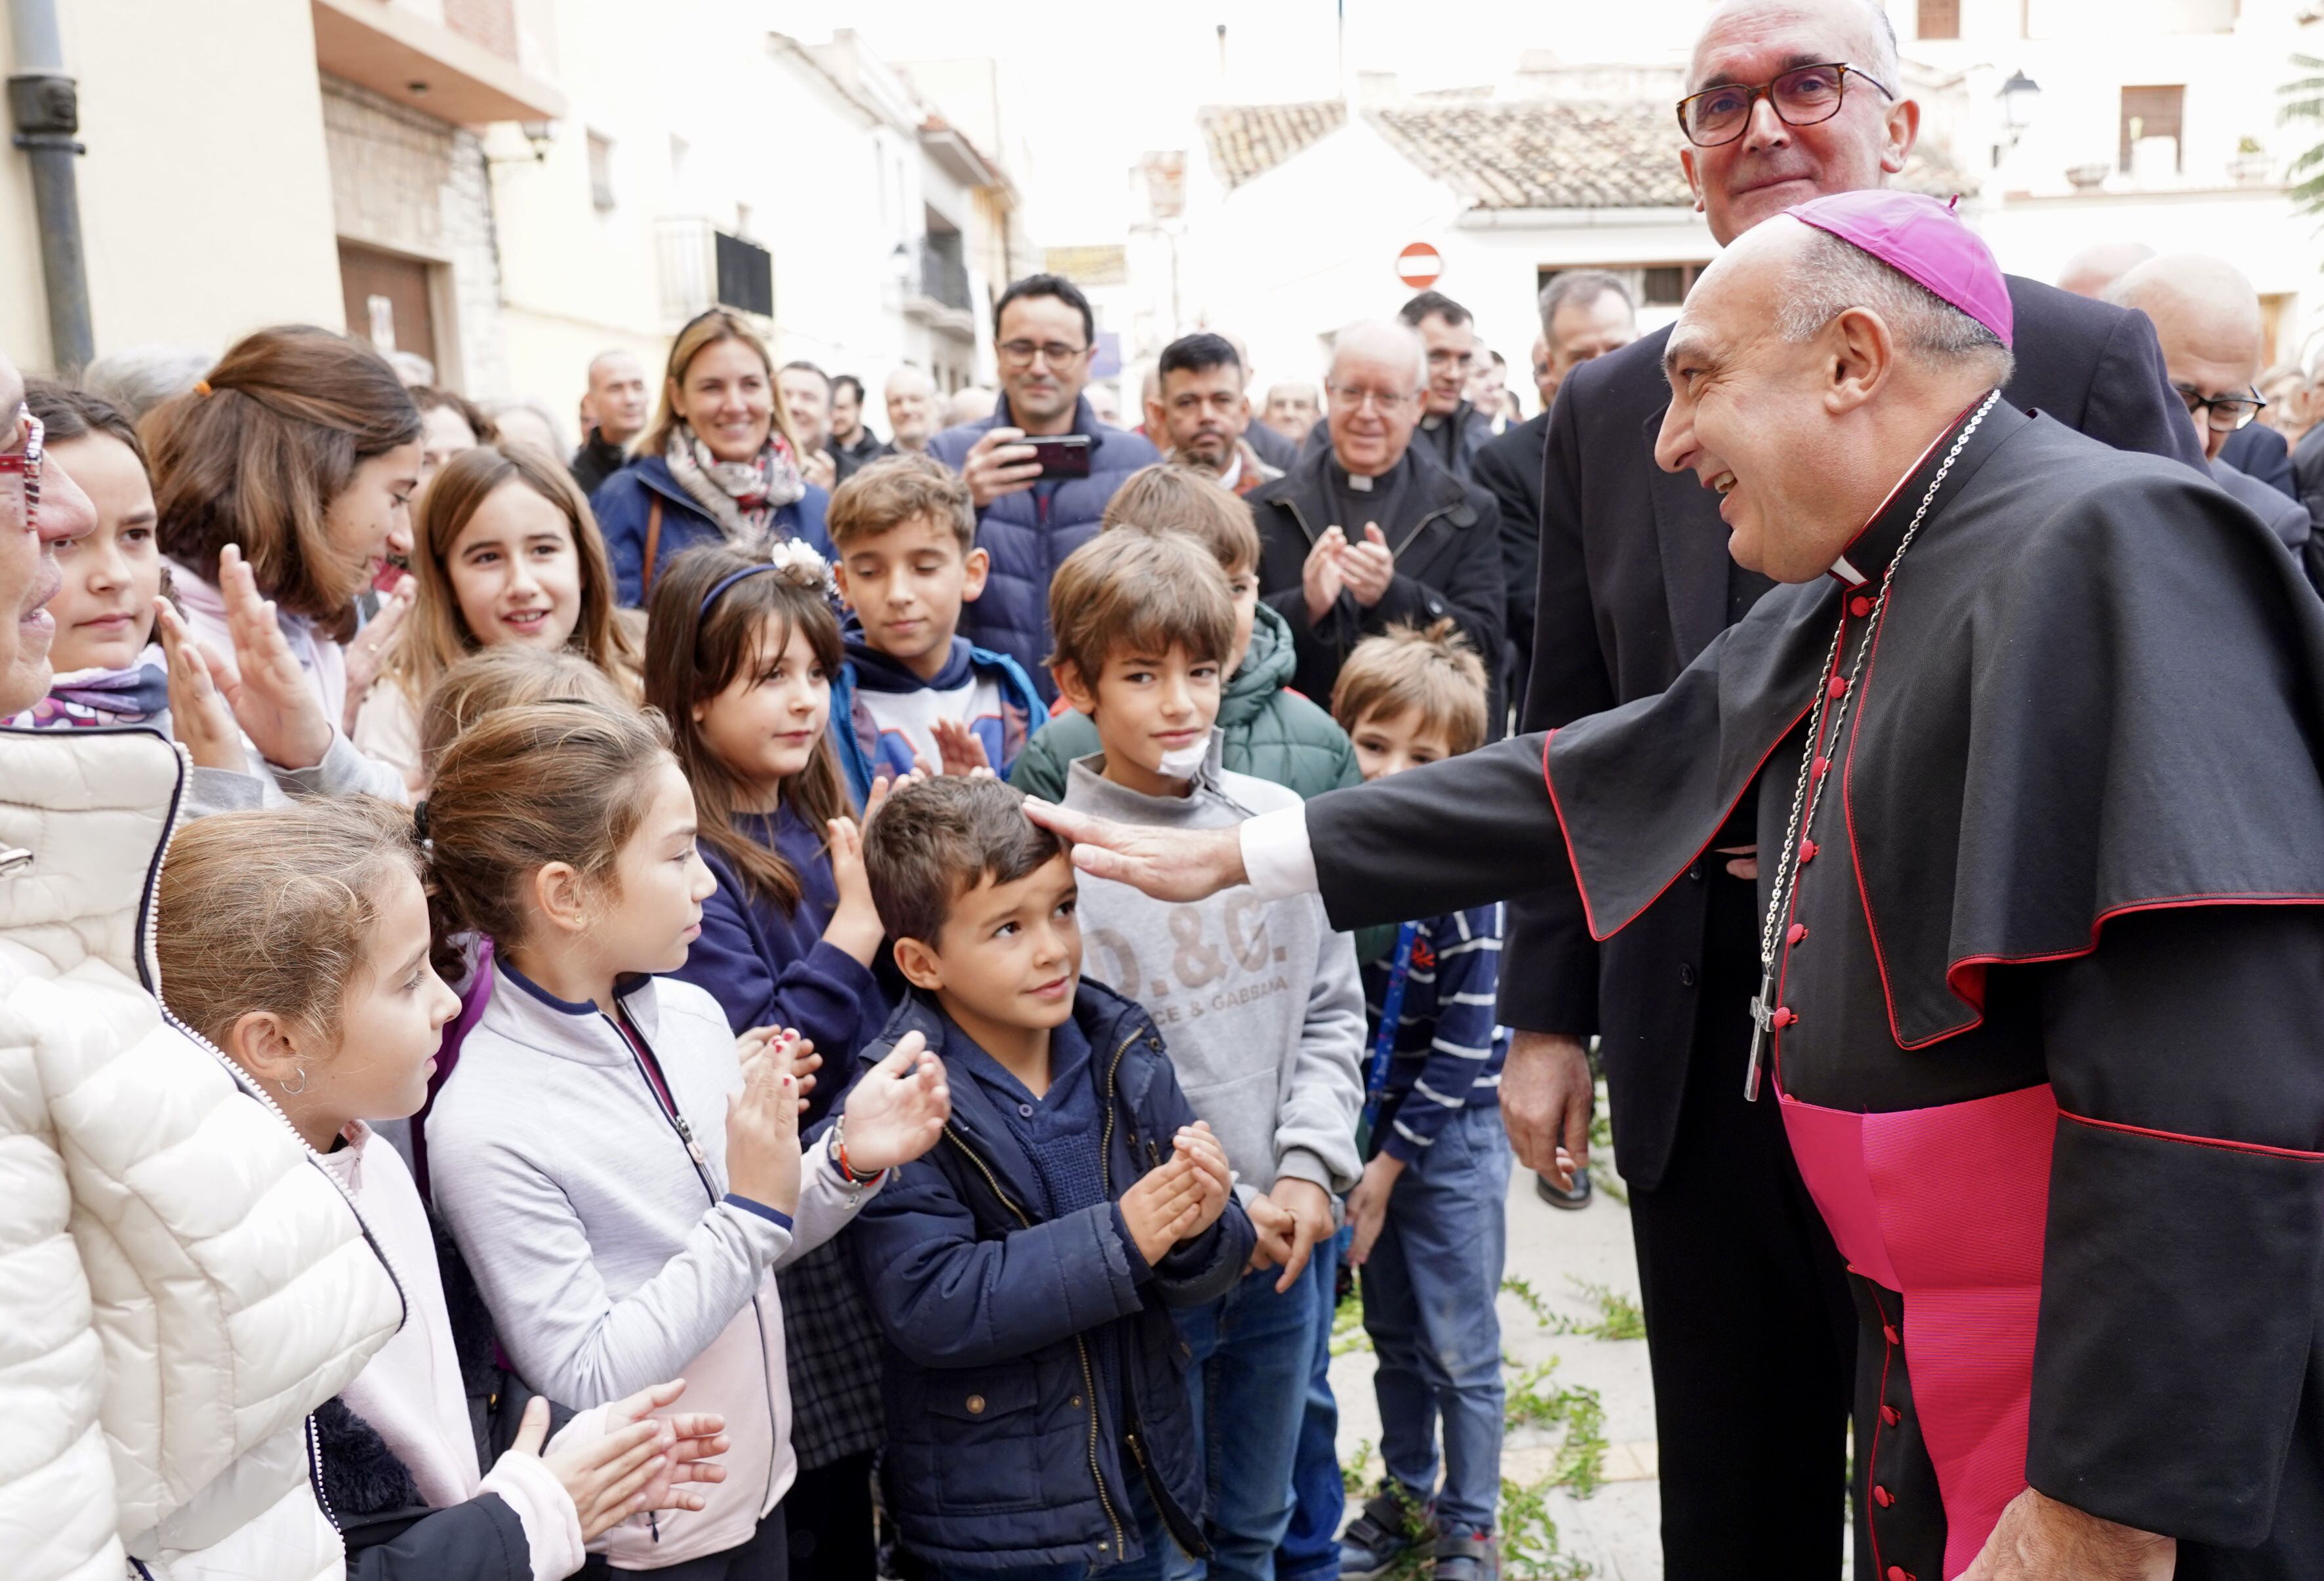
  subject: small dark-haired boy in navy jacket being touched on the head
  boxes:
[855,777,1255,1581]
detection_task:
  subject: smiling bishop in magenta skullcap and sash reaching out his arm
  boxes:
[1036,191,2324,1581]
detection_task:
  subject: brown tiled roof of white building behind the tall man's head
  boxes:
[1202,98,1976,209]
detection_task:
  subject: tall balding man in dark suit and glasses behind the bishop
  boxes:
[1501,0,2203,1581]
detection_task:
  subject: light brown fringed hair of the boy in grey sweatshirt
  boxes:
[1048,533,1234,691]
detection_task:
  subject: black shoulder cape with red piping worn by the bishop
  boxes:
[1545,407,2324,1048]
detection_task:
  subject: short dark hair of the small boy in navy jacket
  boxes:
[865,774,1067,949]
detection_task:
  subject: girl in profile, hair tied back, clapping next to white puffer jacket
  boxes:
[158,798,725,1581]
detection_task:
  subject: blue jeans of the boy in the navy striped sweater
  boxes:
[1362,1109,1508,1532]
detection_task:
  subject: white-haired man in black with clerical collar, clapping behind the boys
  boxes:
[1246,323,1501,735]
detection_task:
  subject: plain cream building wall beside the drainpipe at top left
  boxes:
[0,0,344,367]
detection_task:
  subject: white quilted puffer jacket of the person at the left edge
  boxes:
[0,730,402,1581]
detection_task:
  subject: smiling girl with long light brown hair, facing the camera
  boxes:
[356,444,637,793]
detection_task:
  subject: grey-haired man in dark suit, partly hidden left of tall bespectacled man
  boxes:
[1473,270,1639,734]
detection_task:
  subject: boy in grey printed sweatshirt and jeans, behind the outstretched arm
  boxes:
[1050,528,1364,1581]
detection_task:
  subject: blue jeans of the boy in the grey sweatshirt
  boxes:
[1167,1258,1332,1581]
